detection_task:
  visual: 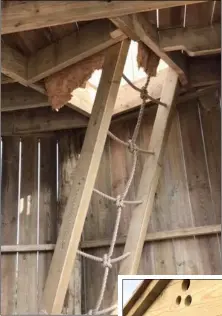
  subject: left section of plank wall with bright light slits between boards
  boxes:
[1,137,57,315]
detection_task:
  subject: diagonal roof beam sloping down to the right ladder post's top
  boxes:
[111,13,188,85]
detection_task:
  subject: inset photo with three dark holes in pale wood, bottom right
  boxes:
[120,276,222,316]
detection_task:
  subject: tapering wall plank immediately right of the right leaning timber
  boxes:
[155,111,200,274]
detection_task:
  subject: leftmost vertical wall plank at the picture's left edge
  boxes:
[1,137,19,315]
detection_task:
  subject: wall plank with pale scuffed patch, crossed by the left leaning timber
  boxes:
[58,131,82,315]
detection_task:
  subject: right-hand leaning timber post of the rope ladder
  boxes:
[114,68,178,315]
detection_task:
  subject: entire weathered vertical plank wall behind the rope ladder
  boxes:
[1,92,222,314]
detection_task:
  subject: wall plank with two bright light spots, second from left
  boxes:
[17,137,38,314]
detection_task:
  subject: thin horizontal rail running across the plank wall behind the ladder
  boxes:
[1,225,221,253]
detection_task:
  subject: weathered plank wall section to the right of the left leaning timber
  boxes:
[80,98,222,312]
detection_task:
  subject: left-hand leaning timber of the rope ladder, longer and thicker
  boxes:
[43,40,130,314]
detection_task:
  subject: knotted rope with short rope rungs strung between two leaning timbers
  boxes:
[41,70,167,315]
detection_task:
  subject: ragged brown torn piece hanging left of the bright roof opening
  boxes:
[45,51,105,109]
